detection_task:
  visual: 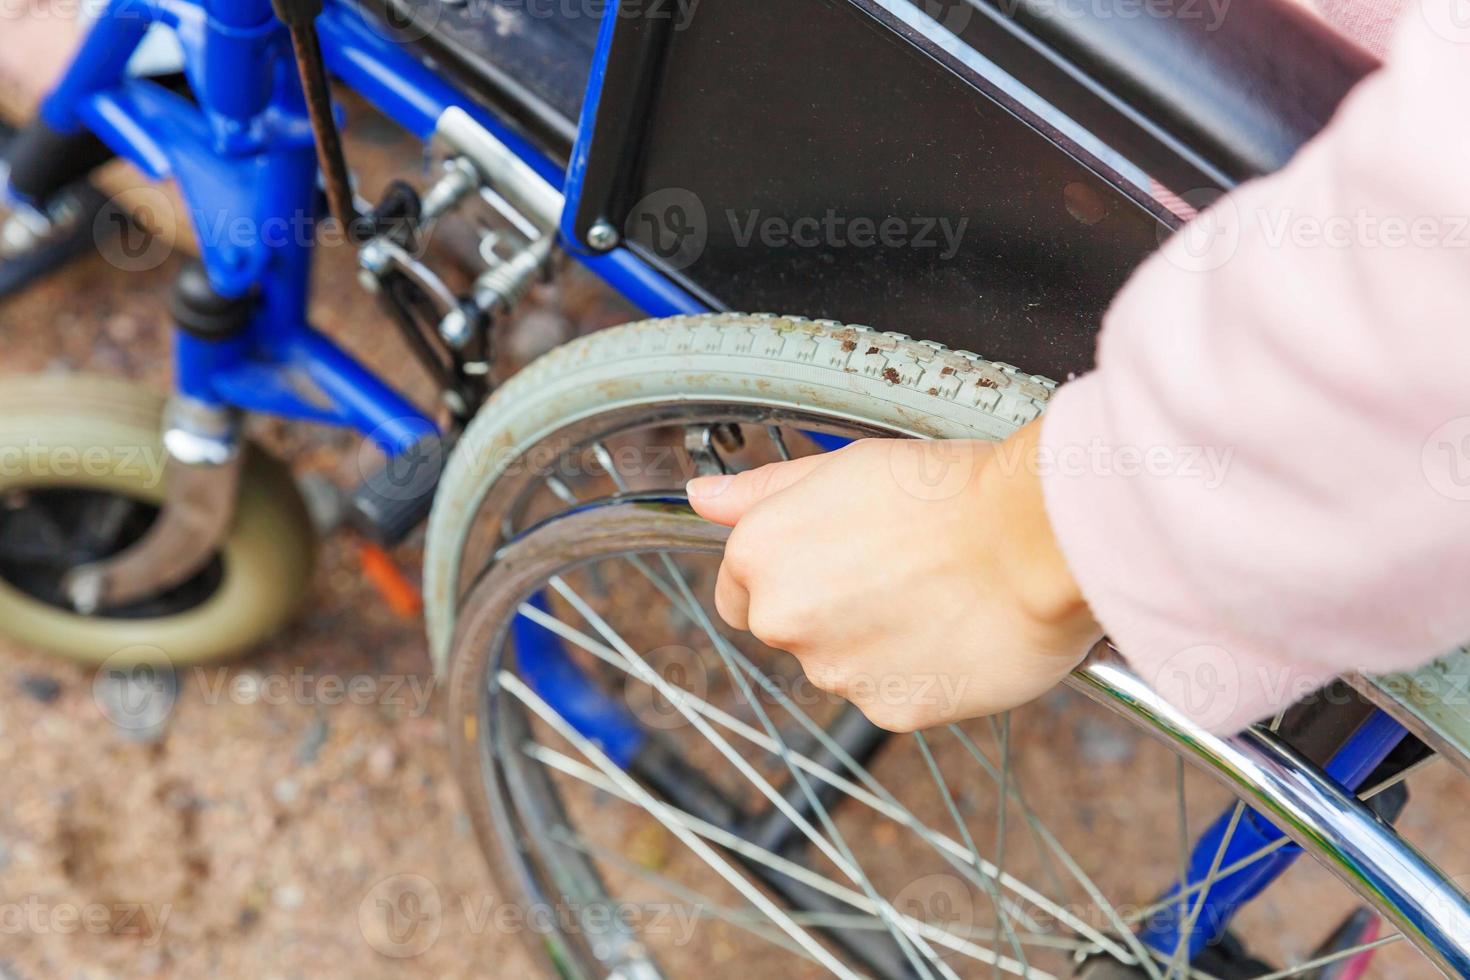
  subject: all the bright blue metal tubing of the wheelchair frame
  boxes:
[8,0,1404,955]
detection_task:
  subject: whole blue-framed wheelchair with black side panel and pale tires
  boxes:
[0,0,1470,980]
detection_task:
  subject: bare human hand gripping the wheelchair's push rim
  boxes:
[688,423,1101,732]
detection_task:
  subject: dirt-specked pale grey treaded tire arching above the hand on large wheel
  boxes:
[423,313,1055,674]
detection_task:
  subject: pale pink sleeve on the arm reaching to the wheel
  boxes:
[1042,0,1470,732]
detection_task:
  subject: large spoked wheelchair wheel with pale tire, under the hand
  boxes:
[426,314,1470,980]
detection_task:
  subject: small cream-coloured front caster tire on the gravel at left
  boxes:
[0,375,315,667]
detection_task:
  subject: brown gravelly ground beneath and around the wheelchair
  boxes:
[0,53,1470,980]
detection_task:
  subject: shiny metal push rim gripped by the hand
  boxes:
[450,500,1470,976]
